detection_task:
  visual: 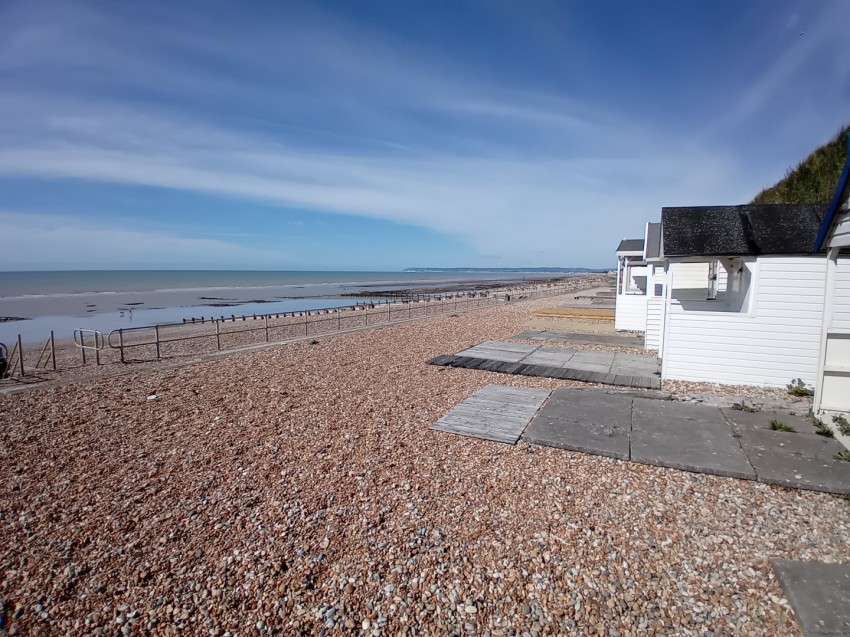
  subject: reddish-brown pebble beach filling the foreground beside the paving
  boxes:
[0,290,850,637]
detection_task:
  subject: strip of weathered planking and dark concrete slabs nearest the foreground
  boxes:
[434,385,850,494]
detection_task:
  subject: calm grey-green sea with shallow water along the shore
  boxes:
[0,269,572,346]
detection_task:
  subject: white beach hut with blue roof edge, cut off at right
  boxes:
[804,137,850,430]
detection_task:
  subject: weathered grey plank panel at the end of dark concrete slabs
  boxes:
[431,385,550,445]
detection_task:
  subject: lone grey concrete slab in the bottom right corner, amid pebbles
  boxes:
[771,560,850,637]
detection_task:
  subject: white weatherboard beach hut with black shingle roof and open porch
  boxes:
[661,204,827,387]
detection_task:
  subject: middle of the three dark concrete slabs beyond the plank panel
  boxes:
[631,418,756,480]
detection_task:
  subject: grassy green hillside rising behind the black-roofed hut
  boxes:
[752,125,850,203]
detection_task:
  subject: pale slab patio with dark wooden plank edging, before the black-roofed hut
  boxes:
[428,341,661,389]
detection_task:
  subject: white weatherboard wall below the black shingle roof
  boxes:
[662,255,826,387]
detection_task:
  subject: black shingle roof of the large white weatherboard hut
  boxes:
[661,204,827,257]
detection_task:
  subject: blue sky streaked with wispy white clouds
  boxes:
[0,0,850,270]
